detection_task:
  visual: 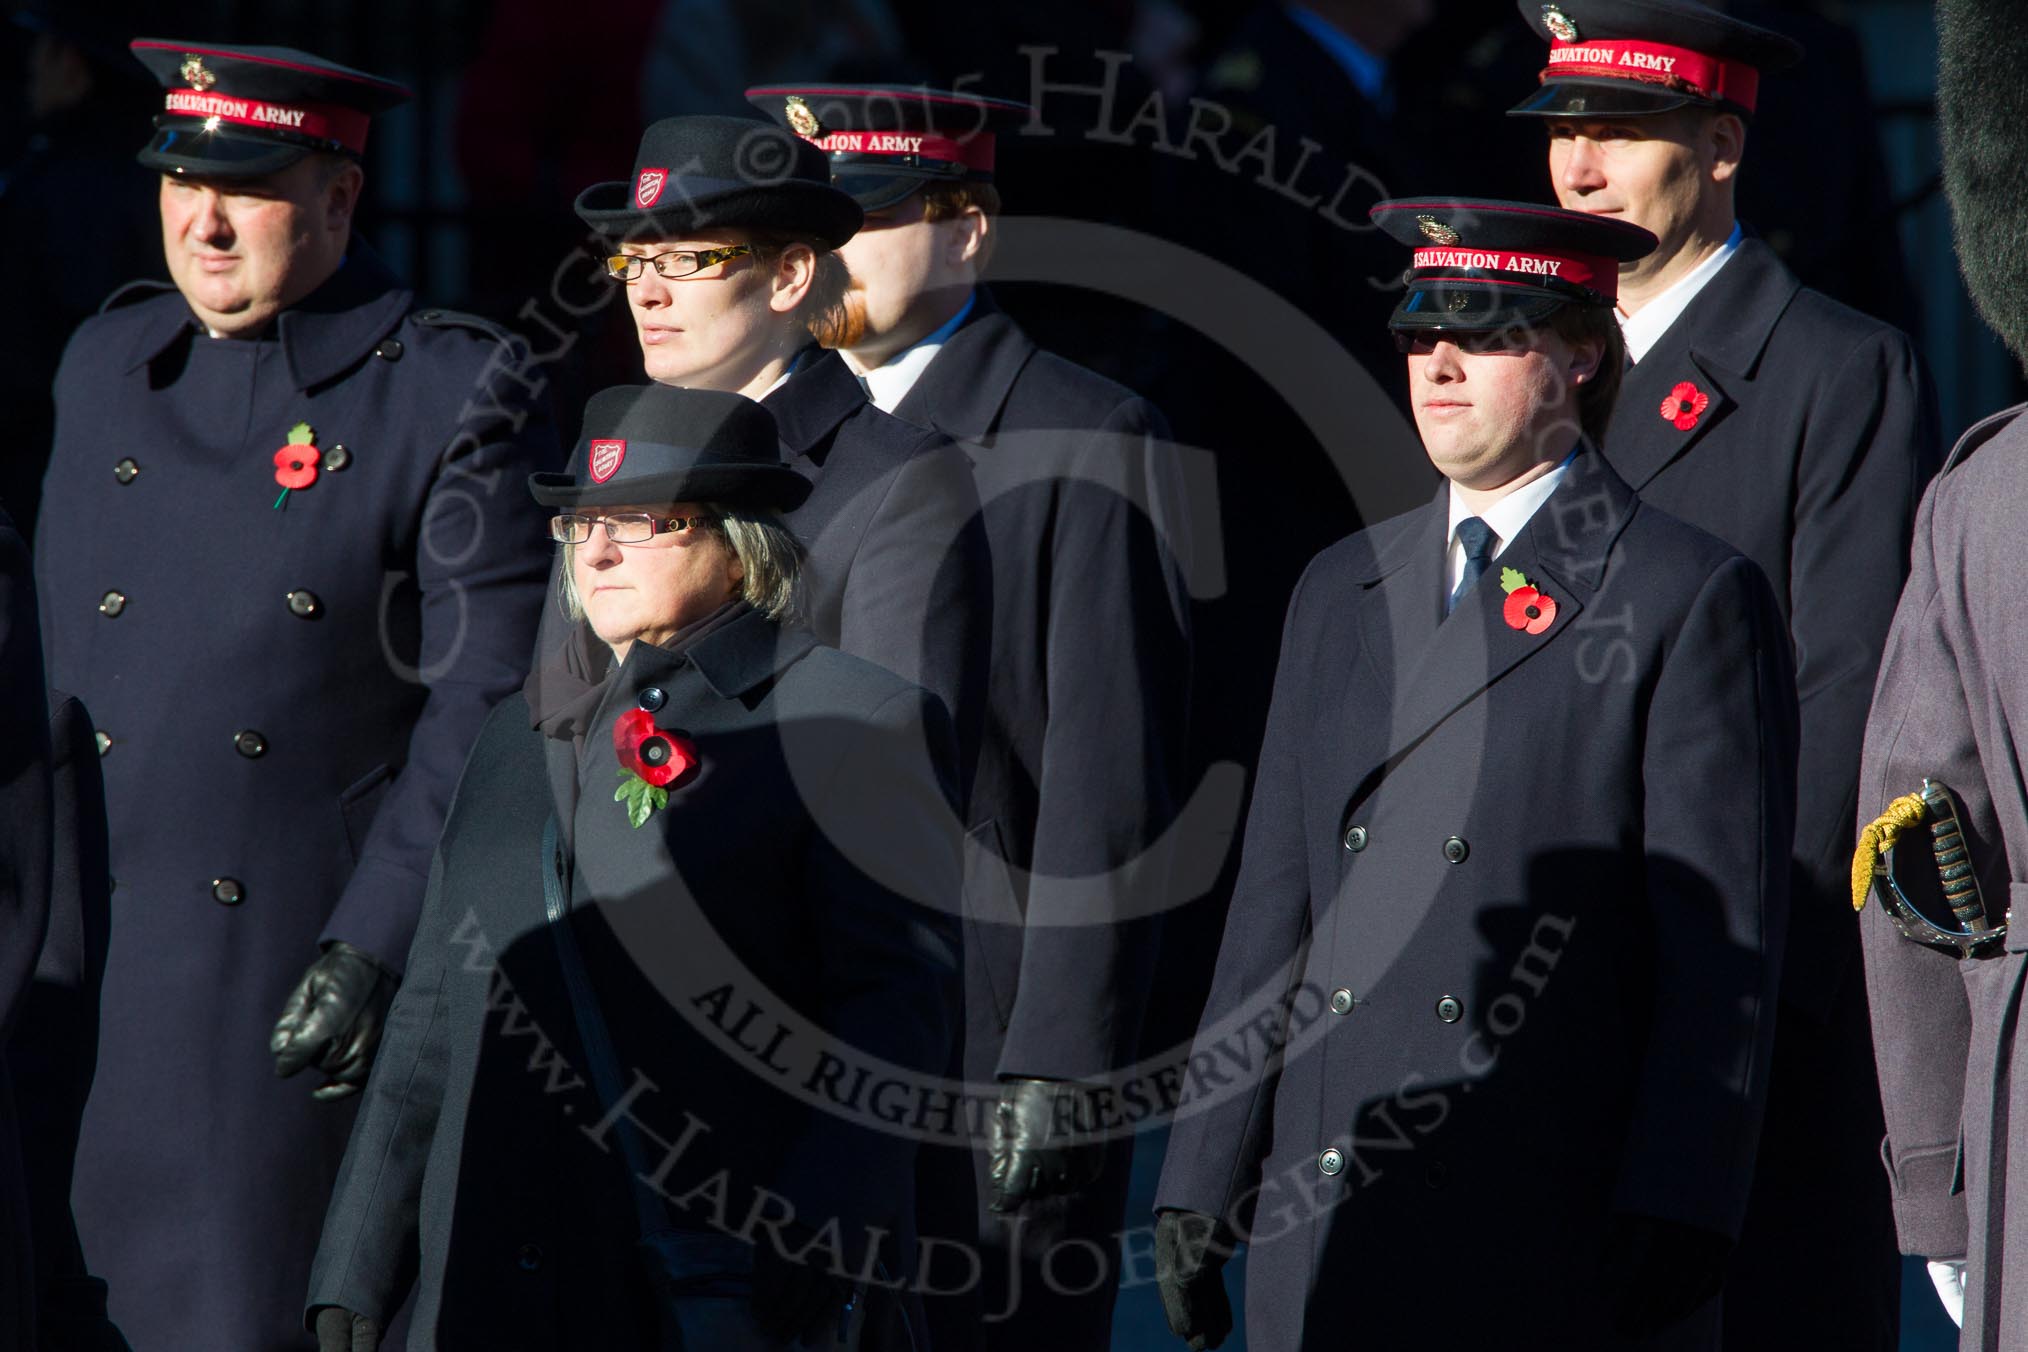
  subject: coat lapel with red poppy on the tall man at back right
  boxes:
[1606,237,1803,491]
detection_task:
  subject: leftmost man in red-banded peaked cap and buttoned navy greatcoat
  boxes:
[37,39,558,1348]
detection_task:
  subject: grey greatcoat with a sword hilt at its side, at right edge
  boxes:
[1856,407,2028,1352]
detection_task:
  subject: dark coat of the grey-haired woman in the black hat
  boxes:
[310,610,959,1352]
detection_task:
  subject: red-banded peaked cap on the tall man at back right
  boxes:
[1507,0,1803,118]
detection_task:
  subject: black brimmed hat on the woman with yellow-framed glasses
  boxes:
[576,116,864,249]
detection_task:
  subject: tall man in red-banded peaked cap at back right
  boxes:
[1513,0,1937,1352]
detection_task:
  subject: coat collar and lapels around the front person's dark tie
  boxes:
[1341,446,1639,814]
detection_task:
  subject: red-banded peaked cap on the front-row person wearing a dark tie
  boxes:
[1369,197,1655,332]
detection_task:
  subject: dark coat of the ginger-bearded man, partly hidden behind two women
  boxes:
[894,290,1190,1348]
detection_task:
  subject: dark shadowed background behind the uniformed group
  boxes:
[0,0,1987,1348]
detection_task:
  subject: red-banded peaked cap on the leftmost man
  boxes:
[130,39,410,178]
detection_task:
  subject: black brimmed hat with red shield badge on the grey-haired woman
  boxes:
[527,385,809,511]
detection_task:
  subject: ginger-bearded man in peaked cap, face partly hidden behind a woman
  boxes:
[748,85,1190,1348]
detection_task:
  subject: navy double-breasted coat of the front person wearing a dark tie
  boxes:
[1156,452,1795,1352]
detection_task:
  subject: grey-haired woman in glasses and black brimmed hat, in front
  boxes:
[310,385,959,1352]
